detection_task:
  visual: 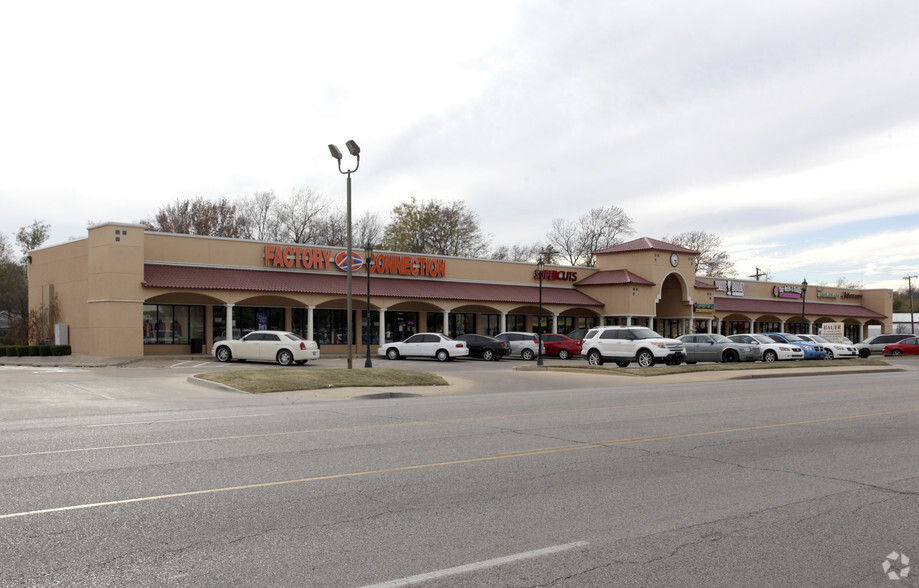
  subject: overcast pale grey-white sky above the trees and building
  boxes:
[0,0,919,288]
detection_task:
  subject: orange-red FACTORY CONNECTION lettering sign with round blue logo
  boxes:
[265,245,447,278]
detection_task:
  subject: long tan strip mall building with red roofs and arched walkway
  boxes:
[29,223,893,357]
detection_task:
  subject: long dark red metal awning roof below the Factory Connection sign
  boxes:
[142,263,602,306]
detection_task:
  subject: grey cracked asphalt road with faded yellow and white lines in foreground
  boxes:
[0,362,919,587]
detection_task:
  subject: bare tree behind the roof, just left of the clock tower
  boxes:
[546,206,635,265]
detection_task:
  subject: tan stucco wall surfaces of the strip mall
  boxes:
[29,223,893,356]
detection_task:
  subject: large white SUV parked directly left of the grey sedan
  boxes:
[581,327,686,367]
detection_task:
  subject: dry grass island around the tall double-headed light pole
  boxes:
[195,367,447,394]
